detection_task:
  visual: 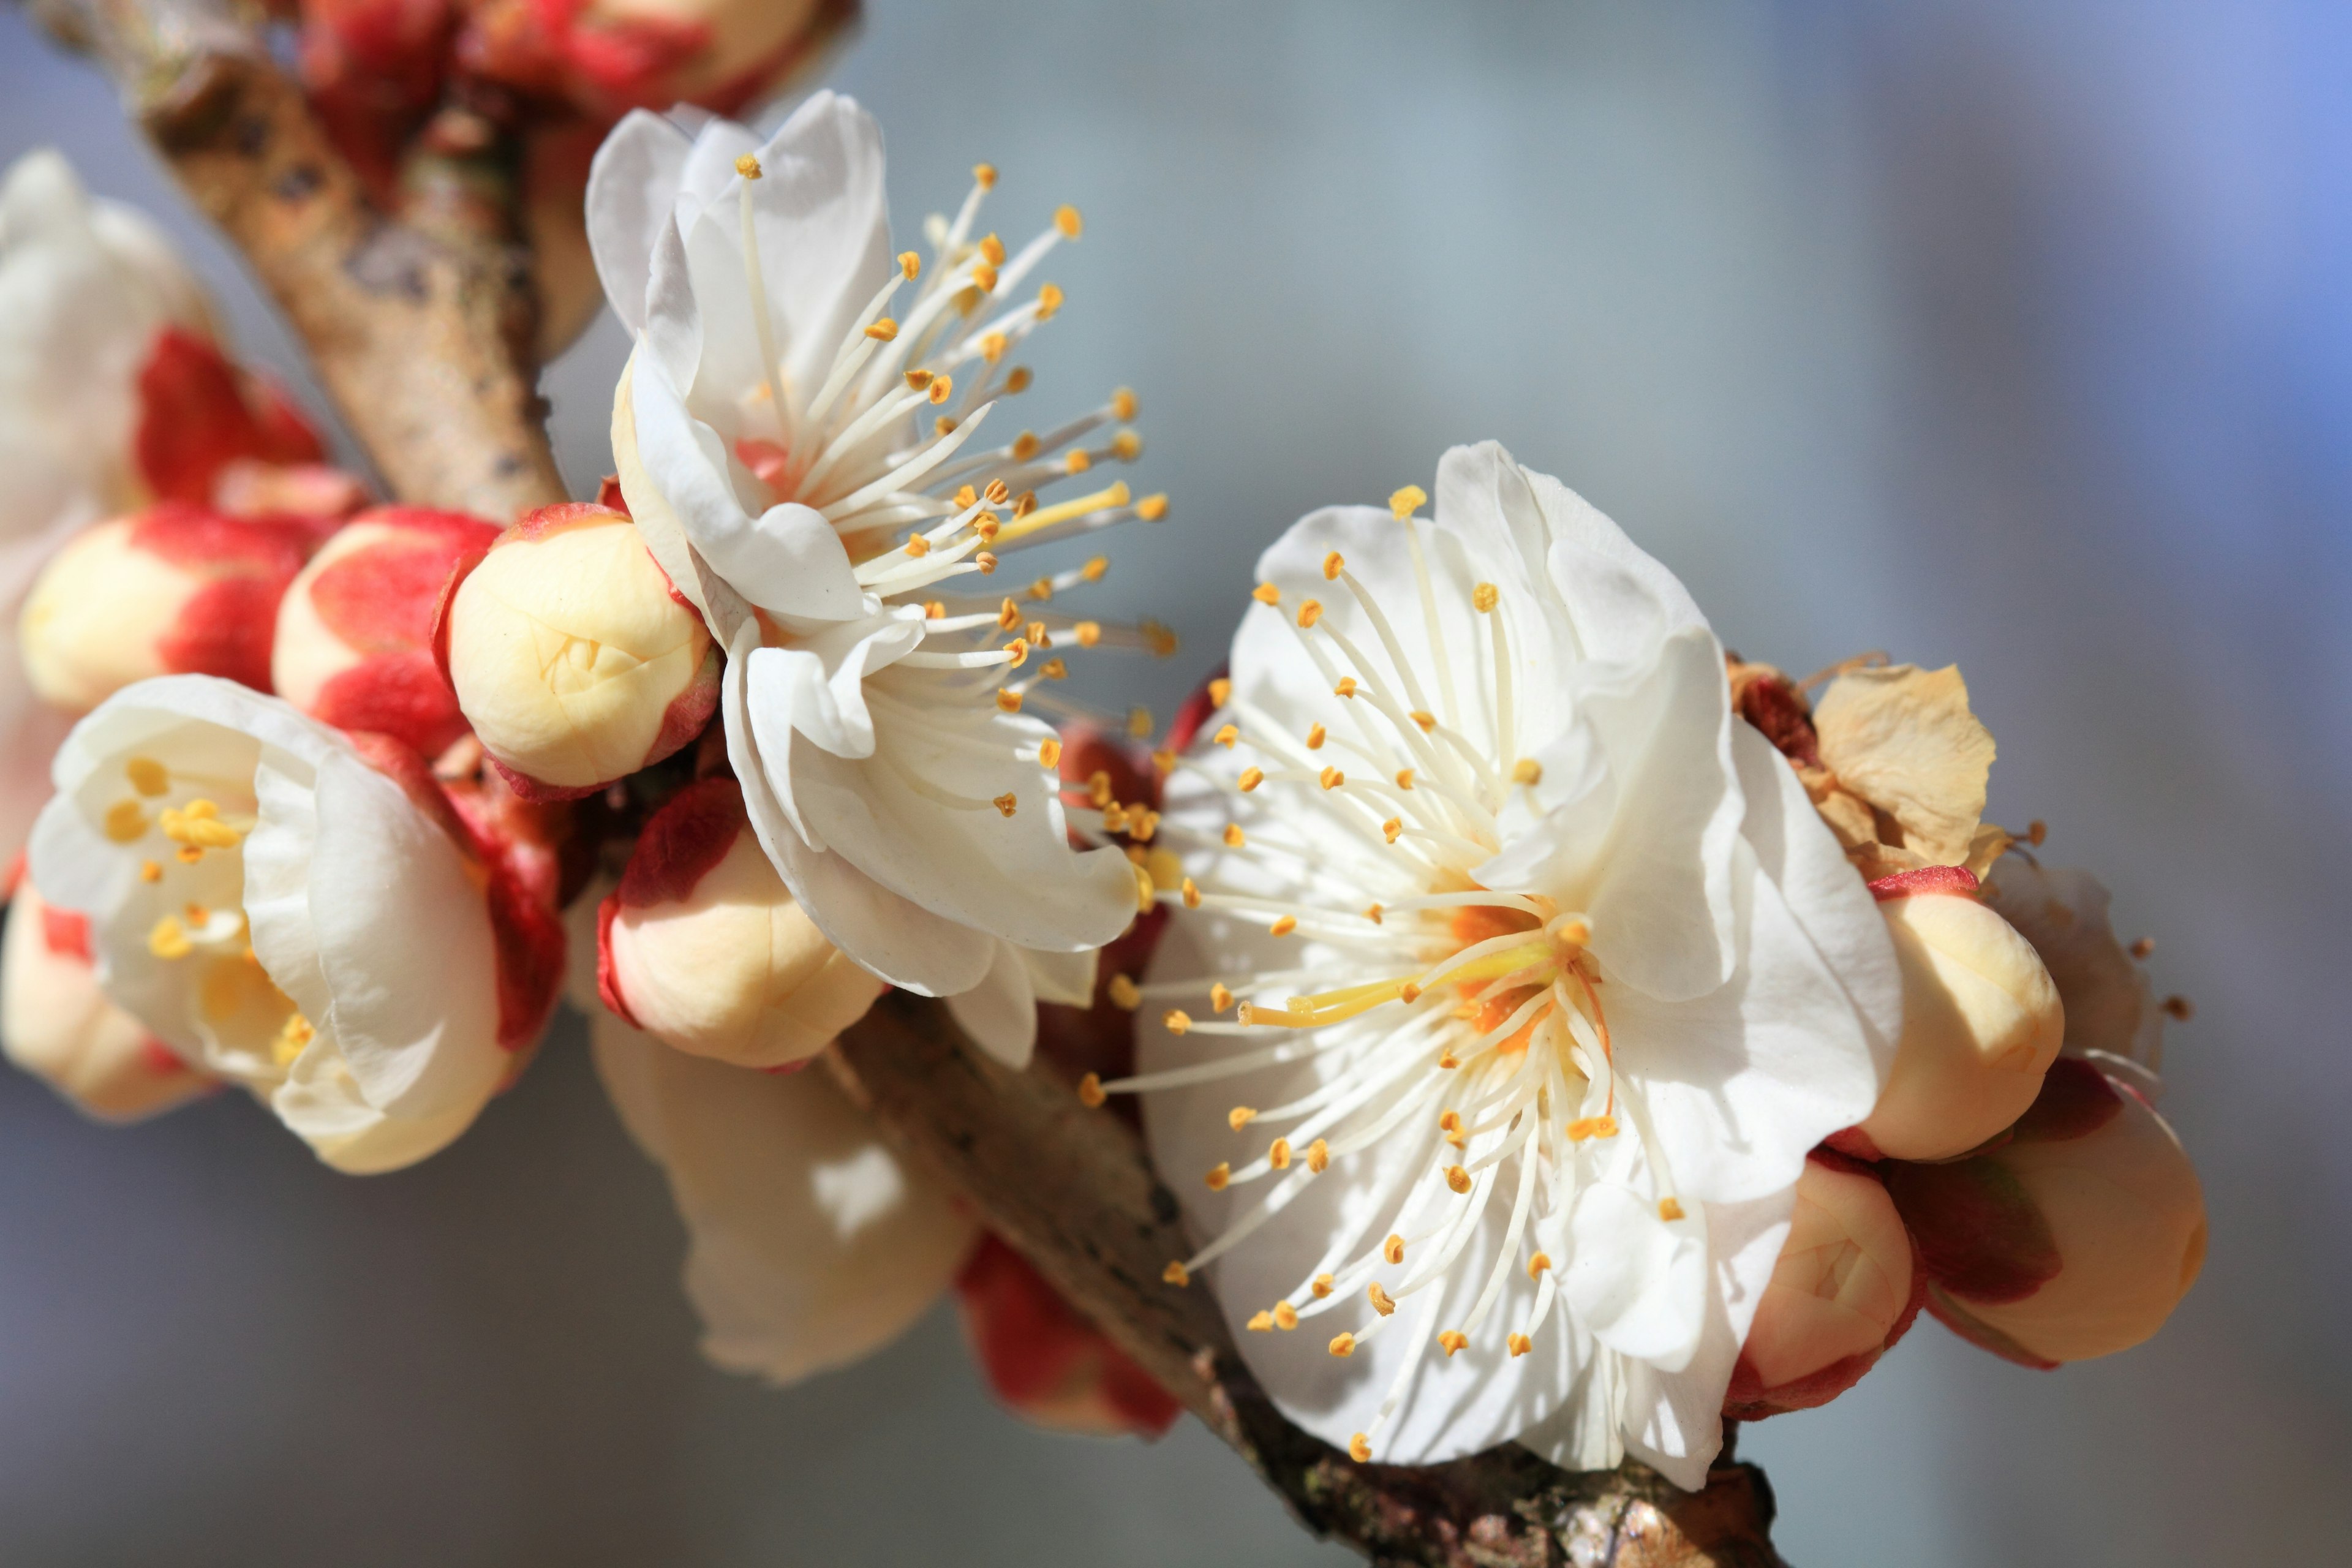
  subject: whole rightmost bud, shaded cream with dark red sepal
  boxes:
[1887,1058,2206,1366]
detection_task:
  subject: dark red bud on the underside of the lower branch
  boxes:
[955,1234,1183,1436]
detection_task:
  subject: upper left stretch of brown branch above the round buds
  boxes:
[28,0,565,522]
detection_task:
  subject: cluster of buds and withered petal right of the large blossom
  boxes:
[1724,663,2206,1417]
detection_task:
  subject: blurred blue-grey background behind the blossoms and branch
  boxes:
[0,0,2352,1568]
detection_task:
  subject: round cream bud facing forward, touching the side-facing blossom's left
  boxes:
[437,505,720,794]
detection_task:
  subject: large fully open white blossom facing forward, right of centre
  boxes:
[1110,444,1901,1488]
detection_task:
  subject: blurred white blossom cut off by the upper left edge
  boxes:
[0,148,209,861]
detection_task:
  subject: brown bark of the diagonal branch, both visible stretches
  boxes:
[26,0,1778,1568]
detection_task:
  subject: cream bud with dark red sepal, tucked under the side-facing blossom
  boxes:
[597,778,882,1067]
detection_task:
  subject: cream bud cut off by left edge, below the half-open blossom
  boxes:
[0,881,212,1121]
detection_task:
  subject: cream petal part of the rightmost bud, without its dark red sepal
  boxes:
[1957,1088,2206,1361]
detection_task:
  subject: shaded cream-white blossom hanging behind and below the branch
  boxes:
[590,1013,978,1382]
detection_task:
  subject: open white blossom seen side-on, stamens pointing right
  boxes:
[588,94,1167,1063]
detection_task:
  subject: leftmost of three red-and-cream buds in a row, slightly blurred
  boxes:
[17,503,313,712]
